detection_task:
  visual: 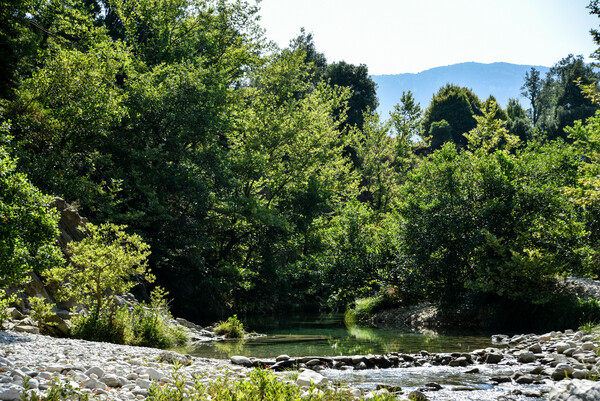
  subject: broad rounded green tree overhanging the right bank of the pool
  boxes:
[398,140,591,303]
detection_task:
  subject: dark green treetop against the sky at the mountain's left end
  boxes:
[325,61,379,129]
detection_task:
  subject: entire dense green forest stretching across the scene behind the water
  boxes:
[0,0,600,330]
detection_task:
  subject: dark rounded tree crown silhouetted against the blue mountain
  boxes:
[423,84,483,149]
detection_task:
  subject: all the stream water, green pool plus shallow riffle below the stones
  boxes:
[180,315,548,401]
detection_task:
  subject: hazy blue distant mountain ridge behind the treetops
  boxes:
[371,62,550,120]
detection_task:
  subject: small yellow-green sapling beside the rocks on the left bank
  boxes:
[45,223,154,313]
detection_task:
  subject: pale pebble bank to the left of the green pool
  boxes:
[0,331,247,400]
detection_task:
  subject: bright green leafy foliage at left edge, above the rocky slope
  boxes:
[0,134,63,288]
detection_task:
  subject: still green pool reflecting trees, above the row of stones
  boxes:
[180,315,491,358]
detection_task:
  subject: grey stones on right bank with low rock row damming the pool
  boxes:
[231,330,600,401]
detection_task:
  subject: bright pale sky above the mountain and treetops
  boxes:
[260,0,600,75]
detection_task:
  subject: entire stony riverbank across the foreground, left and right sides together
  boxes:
[0,330,600,401]
